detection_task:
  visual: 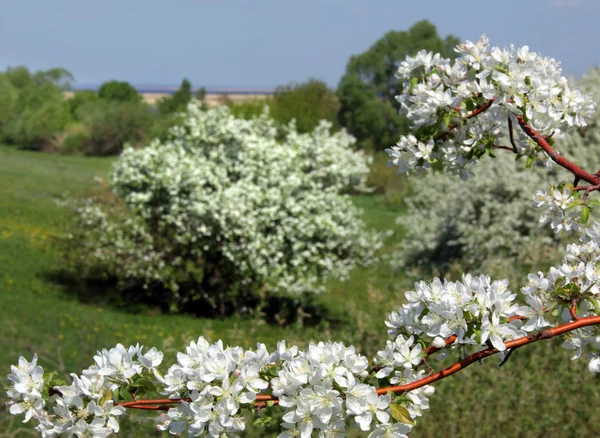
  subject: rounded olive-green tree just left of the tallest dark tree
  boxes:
[270,79,340,132]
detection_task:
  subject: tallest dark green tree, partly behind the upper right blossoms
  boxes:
[337,20,459,150]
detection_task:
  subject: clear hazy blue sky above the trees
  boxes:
[0,0,600,87]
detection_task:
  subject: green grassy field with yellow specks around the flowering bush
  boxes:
[0,147,600,437]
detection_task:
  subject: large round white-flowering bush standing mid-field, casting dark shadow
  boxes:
[67,102,380,313]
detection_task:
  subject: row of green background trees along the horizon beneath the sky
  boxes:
[0,20,458,155]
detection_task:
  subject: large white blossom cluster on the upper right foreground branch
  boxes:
[388,35,595,179]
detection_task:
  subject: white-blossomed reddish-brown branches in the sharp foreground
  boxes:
[8,36,600,438]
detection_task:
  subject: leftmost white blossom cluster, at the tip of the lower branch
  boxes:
[7,344,163,437]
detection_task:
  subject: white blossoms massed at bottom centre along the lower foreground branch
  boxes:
[157,337,426,438]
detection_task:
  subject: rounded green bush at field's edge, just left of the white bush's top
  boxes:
[79,99,152,156]
